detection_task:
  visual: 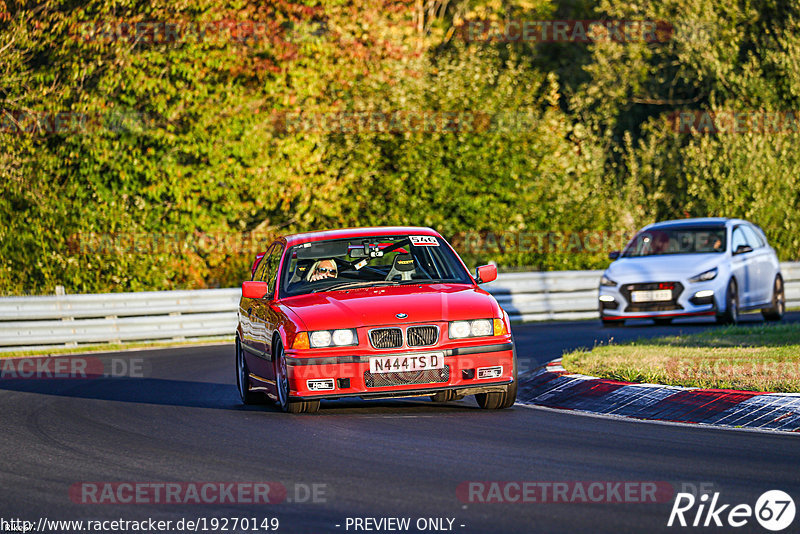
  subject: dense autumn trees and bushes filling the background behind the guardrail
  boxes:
[0,0,800,294]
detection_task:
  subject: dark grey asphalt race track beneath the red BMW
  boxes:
[0,313,800,533]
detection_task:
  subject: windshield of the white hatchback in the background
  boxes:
[622,226,725,258]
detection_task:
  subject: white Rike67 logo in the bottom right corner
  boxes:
[667,490,795,532]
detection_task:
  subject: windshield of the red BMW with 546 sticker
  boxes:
[281,235,472,296]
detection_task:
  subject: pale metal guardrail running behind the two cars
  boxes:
[0,263,800,351]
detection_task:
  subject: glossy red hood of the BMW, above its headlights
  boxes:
[281,284,499,330]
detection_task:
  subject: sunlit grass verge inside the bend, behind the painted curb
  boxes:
[562,324,800,393]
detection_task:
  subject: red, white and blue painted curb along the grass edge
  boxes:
[517,359,800,432]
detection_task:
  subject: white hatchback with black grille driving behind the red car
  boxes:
[599,218,786,325]
